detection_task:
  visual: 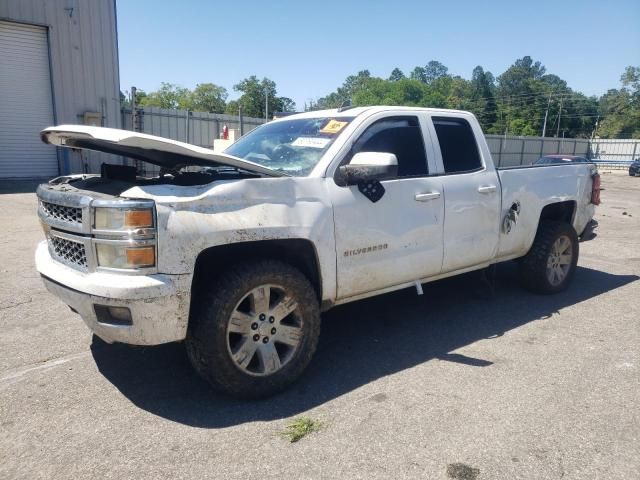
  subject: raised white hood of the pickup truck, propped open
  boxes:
[40,125,287,177]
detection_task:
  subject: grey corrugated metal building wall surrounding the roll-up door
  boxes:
[0,0,121,173]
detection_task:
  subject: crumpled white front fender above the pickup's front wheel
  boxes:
[127,177,336,299]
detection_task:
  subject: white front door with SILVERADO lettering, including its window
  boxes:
[328,115,444,299]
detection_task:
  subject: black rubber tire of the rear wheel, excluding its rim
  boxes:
[520,220,579,294]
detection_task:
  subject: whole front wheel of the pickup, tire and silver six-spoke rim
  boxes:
[186,260,320,398]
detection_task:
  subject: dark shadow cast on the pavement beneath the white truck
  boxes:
[91,263,640,428]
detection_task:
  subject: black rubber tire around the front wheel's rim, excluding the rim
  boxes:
[186,260,320,398]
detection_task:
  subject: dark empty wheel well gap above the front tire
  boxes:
[192,238,322,300]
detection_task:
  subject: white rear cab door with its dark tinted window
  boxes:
[431,115,500,273]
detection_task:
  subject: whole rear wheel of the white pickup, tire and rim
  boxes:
[520,220,579,294]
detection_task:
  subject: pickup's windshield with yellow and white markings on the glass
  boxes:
[224,117,353,177]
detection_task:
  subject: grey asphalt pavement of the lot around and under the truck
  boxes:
[0,172,640,480]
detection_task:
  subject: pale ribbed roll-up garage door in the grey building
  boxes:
[0,21,58,178]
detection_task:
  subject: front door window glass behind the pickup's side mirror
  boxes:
[352,117,429,177]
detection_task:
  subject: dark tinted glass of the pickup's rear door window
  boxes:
[433,117,482,173]
